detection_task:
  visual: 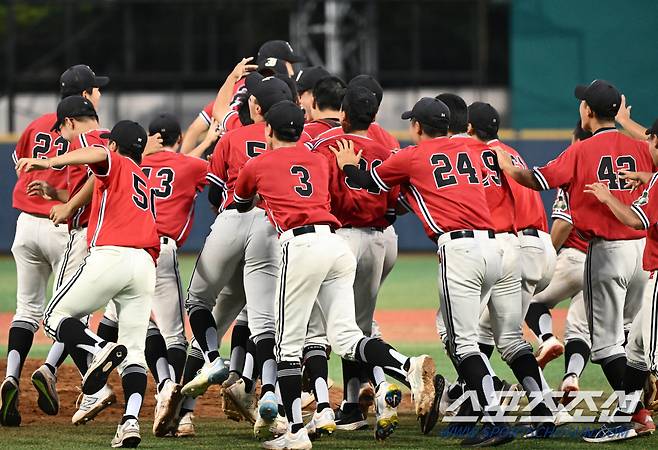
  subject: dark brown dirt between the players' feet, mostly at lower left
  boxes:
[0,359,411,427]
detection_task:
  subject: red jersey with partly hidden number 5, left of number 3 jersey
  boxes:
[208,122,267,212]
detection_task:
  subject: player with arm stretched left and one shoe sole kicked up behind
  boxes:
[18,116,160,447]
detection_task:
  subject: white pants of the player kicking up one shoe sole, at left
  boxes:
[44,246,155,372]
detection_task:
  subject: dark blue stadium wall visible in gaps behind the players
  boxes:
[0,139,568,253]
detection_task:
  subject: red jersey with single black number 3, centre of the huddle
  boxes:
[235,147,340,233]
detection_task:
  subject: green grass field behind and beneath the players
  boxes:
[0,254,658,449]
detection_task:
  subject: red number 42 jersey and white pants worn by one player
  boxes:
[533,128,653,364]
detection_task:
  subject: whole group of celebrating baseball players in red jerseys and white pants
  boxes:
[0,41,658,449]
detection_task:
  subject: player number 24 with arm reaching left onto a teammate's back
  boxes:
[328,98,513,445]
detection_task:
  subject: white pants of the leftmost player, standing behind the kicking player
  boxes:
[11,212,68,331]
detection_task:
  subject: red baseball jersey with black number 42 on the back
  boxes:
[534,128,653,240]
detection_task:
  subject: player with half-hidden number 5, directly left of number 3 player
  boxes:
[179,73,292,440]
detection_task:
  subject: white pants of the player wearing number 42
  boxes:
[583,238,648,362]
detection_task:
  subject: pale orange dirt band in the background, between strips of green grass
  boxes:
[0,309,567,344]
